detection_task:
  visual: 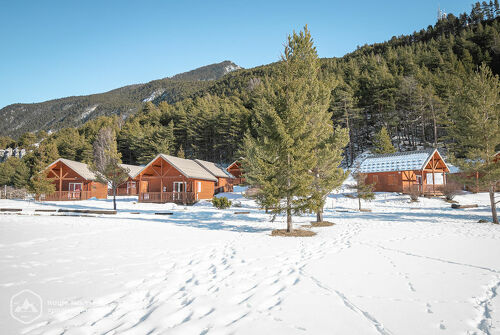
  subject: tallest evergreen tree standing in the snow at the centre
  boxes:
[243,26,328,232]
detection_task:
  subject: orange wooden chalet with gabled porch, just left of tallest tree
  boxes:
[137,154,218,204]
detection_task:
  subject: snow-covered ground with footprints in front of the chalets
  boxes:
[0,192,500,335]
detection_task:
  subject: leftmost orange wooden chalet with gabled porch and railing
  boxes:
[38,158,108,201]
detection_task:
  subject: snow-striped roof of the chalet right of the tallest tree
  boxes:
[360,149,436,173]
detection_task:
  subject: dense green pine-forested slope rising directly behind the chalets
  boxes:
[0,1,500,173]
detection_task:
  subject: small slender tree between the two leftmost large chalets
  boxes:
[90,128,129,210]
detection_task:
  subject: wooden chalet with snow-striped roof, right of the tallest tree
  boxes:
[360,149,450,195]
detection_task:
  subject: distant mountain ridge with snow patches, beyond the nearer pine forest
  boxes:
[0,61,240,137]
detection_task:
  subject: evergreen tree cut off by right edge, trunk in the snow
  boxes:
[450,64,500,224]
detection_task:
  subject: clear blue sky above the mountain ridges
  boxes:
[0,0,473,108]
